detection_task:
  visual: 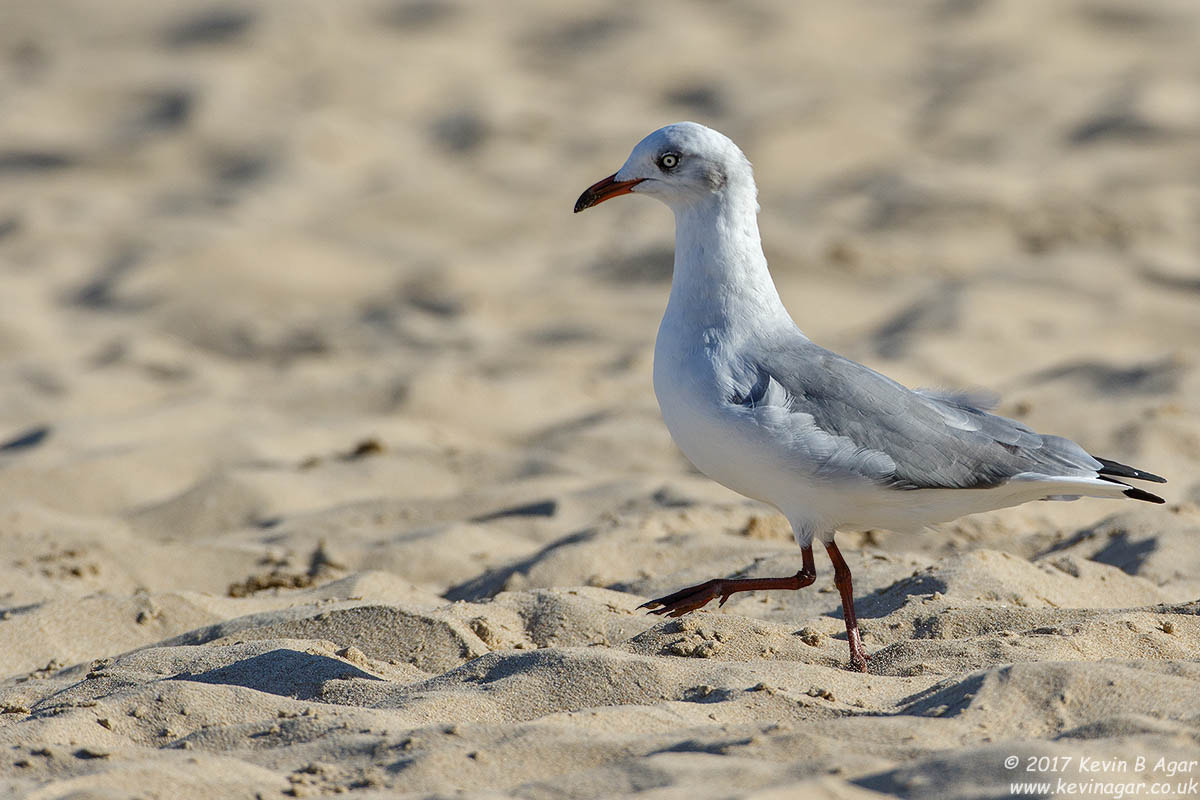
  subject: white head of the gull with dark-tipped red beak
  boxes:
[575,122,755,213]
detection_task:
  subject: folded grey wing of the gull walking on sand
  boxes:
[743,339,1102,489]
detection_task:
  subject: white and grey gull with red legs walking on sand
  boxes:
[575,122,1165,672]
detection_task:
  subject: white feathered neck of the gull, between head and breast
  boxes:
[666,182,791,331]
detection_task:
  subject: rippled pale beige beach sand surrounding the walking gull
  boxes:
[0,0,1200,800]
